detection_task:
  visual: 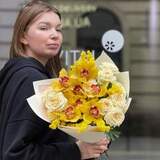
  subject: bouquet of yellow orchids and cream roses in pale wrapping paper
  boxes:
[27,51,131,158]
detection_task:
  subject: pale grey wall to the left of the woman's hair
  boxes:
[0,0,24,68]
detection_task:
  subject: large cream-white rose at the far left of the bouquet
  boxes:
[43,90,67,112]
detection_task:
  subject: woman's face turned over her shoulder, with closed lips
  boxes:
[21,12,62,63]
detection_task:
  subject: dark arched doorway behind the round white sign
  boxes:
[77,8,122,70]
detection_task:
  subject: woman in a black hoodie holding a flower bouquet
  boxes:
[0,1,108,160]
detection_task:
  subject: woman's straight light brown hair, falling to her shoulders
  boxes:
[10,0,61,75]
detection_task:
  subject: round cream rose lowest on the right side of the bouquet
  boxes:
[104,108,125,127]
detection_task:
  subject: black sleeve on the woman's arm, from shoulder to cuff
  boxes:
[3,71,81,160]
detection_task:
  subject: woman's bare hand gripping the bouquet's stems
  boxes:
[76,138,109,159]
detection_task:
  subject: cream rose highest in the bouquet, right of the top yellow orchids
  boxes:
[98,62,119,83]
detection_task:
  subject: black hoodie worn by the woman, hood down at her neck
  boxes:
[0,57,81,160]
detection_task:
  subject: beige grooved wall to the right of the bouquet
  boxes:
[111,0,160,114]
